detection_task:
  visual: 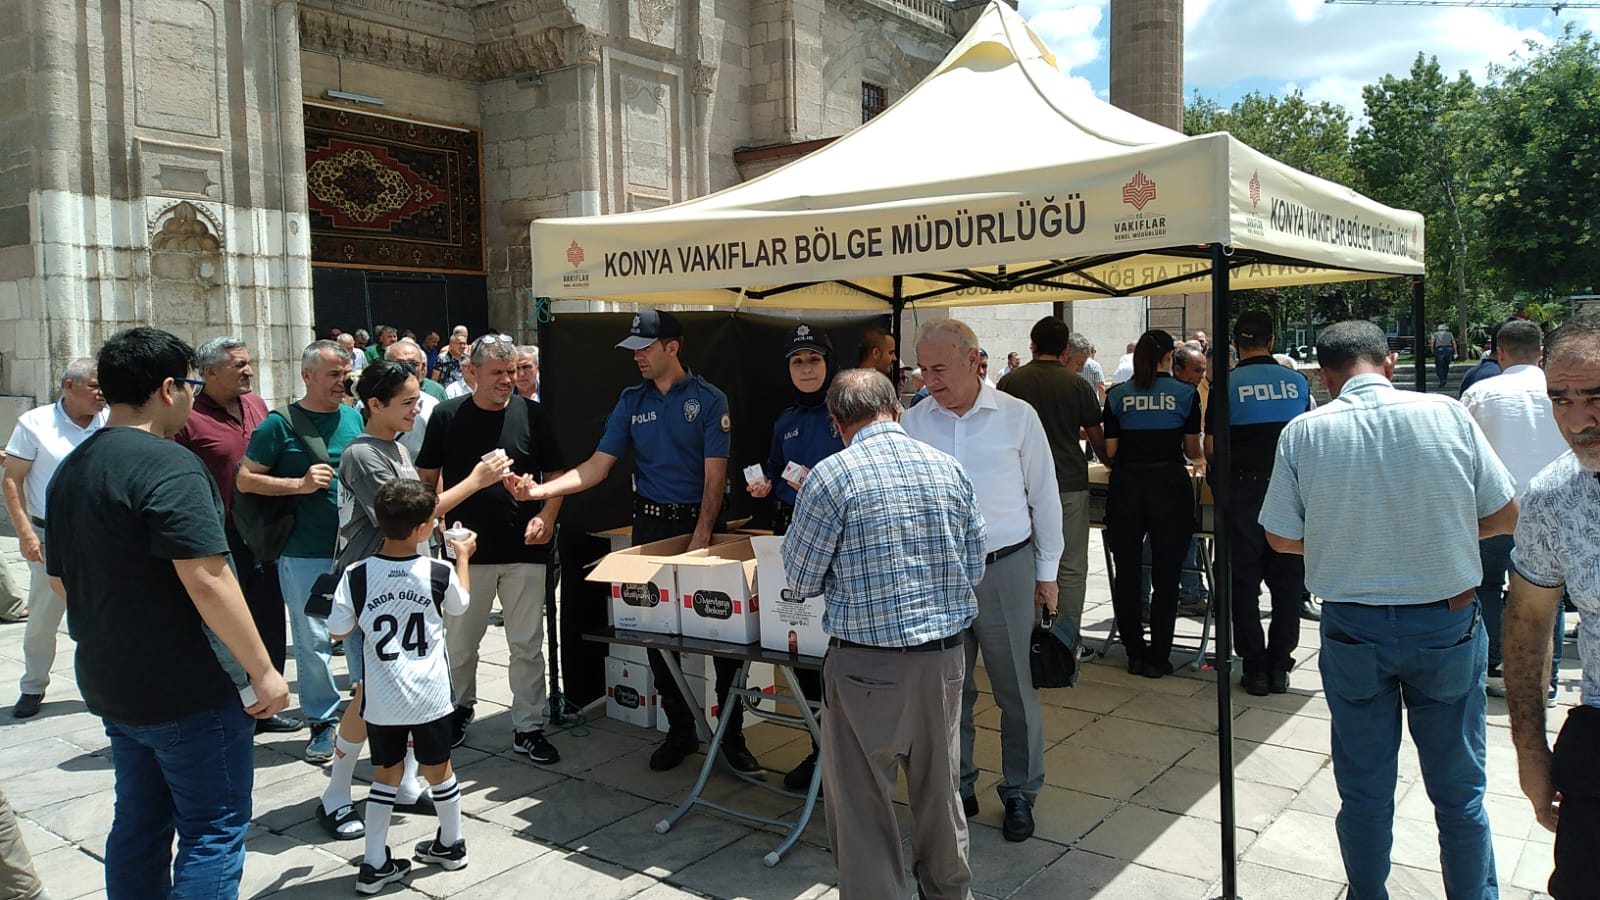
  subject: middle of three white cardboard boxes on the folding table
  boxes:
[674,538,762,644]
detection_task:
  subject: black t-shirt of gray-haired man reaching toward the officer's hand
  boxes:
[416,394,566,565]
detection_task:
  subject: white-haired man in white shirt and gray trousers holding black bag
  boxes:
[901,319,1064,841]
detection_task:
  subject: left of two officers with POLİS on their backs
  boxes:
[1101,330,1200,677]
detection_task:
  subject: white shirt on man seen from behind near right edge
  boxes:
[1461,365,1566,496]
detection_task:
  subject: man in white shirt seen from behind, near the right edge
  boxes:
[1461,319,1566,705]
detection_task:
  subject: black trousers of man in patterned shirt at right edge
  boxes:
[1547,706,1600,900]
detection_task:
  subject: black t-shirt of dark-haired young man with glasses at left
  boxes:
[45,428,240,725]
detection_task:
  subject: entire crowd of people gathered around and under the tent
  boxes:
[3,304,1600,898]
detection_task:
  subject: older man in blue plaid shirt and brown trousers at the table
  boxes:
[784,368,987,900]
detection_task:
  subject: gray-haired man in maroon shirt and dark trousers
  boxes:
[173,336,301,733]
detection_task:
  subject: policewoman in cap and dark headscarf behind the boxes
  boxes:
[746,323,845,791]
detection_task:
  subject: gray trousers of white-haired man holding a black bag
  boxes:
[962,543,1045,804]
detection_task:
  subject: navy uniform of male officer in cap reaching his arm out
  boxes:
[598,373,744,746]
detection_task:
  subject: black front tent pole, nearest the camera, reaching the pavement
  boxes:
[1208,243,1238,900]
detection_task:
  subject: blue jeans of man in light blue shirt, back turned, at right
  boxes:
[1320,601,1499,900]
